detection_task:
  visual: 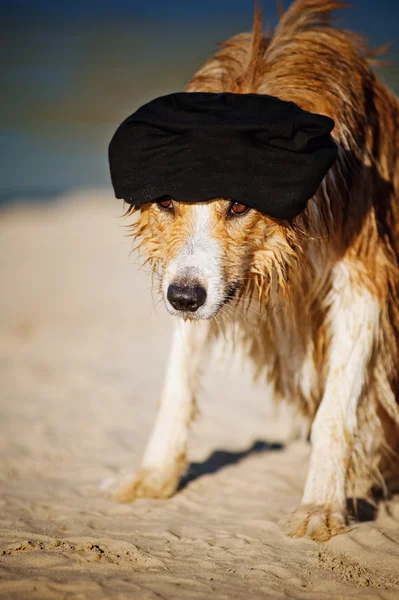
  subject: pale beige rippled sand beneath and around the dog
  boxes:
[0,190,399,600]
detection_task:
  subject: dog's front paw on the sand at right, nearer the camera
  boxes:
[282,504,348,542]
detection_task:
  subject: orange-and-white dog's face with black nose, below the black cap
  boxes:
[133,198,297,319]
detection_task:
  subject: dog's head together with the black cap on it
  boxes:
[109,92,337,319]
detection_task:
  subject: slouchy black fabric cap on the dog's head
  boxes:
[109,92,338,219]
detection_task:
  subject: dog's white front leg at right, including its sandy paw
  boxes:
[285,263,380,541]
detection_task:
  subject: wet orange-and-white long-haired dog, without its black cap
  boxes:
[107,0,399,541]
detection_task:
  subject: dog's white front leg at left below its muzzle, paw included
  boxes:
[108,321,209,502]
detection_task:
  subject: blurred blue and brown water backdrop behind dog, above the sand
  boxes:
[0,0,399,202]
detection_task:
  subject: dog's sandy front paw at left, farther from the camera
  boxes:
[101,468,184,502]
